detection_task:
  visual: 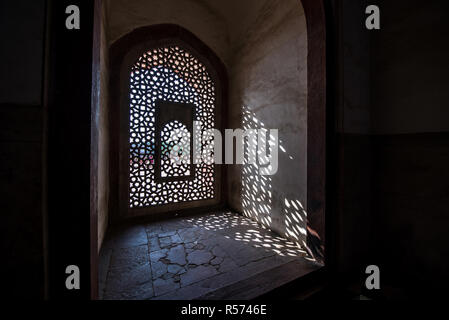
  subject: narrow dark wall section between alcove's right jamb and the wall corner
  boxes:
[328,0,374,274]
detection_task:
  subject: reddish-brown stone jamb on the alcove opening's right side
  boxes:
[301,0,331,263]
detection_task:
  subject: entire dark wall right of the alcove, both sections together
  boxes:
[329,0,449,296]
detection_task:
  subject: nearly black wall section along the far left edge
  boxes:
[0,0,45,299]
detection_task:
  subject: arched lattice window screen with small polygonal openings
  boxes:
[129,46,216,208]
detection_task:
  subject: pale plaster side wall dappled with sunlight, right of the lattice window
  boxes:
[228,0,307,243]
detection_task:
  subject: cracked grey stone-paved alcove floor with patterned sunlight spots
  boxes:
[99,212,315,300]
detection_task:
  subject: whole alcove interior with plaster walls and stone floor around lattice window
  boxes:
[97,0,325,299]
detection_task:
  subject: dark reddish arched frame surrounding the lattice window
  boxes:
[109,24,228,222]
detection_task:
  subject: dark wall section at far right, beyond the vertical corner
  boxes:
[371,0,449,297]
